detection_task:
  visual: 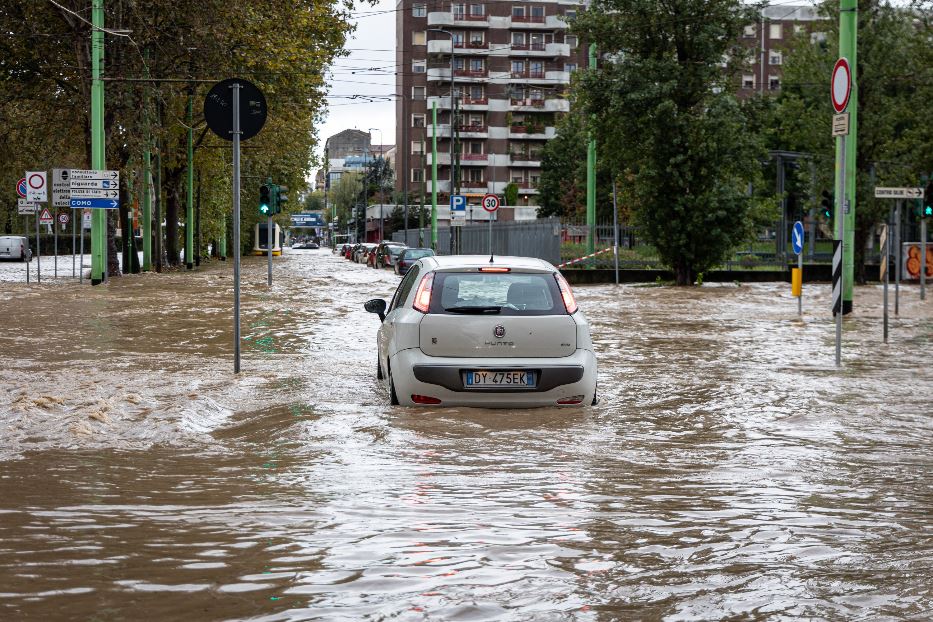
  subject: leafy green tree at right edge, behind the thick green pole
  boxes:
[778,0,933,283]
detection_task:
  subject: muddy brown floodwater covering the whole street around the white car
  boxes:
[0,249,933,621]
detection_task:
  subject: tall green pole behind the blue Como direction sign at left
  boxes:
[91,0,107,285]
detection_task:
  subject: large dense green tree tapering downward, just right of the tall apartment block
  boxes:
[573,0,763,285]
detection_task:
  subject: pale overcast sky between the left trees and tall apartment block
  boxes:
[318,0,395,180]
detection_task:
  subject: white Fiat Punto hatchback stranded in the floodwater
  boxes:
[364,255,596,407]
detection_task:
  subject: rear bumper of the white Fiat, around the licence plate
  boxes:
[390,348,596,408]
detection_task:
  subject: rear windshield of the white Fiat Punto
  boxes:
[430,272,566,315]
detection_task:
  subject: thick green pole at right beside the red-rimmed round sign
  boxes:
[836,0,858,315]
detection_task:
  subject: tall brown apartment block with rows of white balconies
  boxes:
[396,0,586,220]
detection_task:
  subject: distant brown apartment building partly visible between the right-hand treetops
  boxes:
[736,5,826,97]
